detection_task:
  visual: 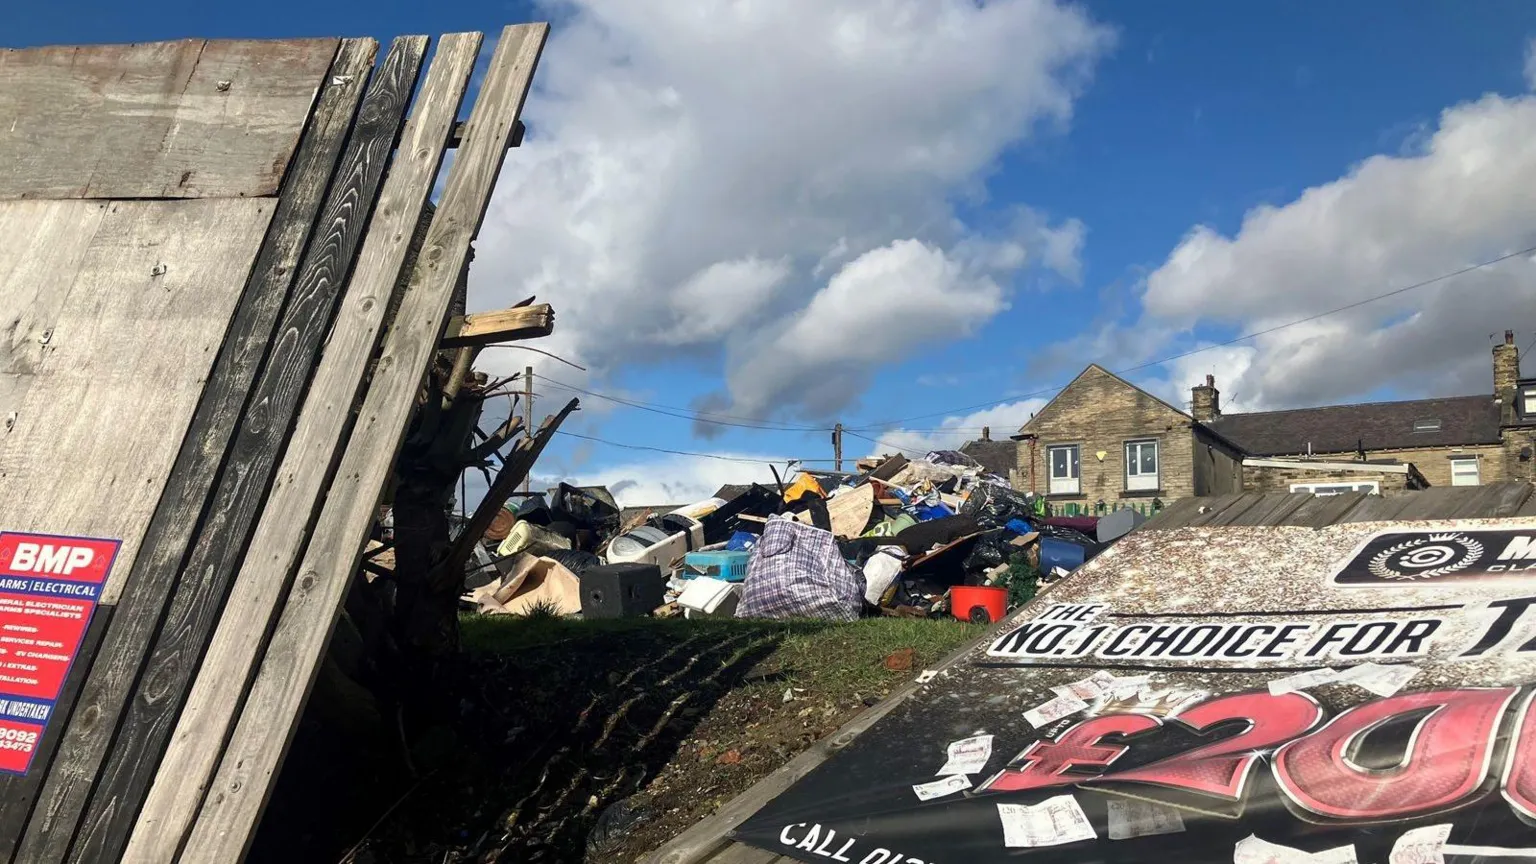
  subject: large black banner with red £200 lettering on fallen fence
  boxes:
[734,520,1536,864]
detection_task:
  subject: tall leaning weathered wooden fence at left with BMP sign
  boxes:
[0,25,548,864]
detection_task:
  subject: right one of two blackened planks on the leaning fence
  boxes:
[57,37,427,862]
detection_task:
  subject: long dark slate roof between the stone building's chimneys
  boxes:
[1206,397,1499,457]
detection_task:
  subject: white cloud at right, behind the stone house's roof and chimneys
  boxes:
[1137,89,1536,407]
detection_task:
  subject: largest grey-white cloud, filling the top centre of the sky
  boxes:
[470,0,1112,415]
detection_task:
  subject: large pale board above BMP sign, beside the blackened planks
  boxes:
[0,198,273,860]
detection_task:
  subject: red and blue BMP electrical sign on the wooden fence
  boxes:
[0,532,120,773]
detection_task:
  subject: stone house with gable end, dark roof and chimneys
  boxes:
[1012,332,1536,509]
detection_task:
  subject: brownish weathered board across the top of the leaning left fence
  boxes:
[0,38,336,198]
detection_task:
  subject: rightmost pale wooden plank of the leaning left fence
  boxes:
[181,23,548,861]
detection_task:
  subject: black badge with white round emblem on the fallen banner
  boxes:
[1329,529,1536,587]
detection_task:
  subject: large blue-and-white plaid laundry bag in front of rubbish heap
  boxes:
[736,518,865,621]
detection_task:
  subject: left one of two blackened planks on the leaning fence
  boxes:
[6,40,378,860]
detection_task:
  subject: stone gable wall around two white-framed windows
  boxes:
[1017,366,1195,506]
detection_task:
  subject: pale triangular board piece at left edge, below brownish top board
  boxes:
[0,201,106,420]
